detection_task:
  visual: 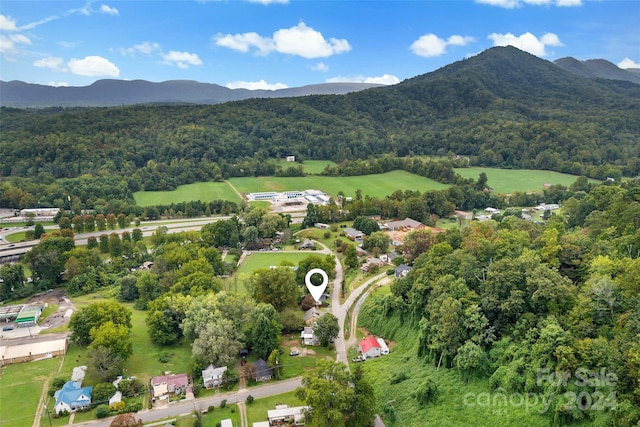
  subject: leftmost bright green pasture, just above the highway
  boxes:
[133,182,240,206]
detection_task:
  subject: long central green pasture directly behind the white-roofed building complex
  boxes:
[229,170,448,197]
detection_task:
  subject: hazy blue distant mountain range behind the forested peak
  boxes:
[0,51,640,108]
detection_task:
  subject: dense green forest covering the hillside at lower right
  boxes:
[361,181,640,426]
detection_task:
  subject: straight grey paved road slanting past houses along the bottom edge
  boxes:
[73,377,302,427]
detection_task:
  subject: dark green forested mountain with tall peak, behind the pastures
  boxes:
[0,47,640,191]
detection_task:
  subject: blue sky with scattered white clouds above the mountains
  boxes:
[0,0,640,89]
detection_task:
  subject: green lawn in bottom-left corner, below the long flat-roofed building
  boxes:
[0,357,60,427]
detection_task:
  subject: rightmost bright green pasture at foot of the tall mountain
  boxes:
[454,168,598,193]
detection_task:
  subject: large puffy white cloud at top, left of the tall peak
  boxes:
[218,22,351,59]
